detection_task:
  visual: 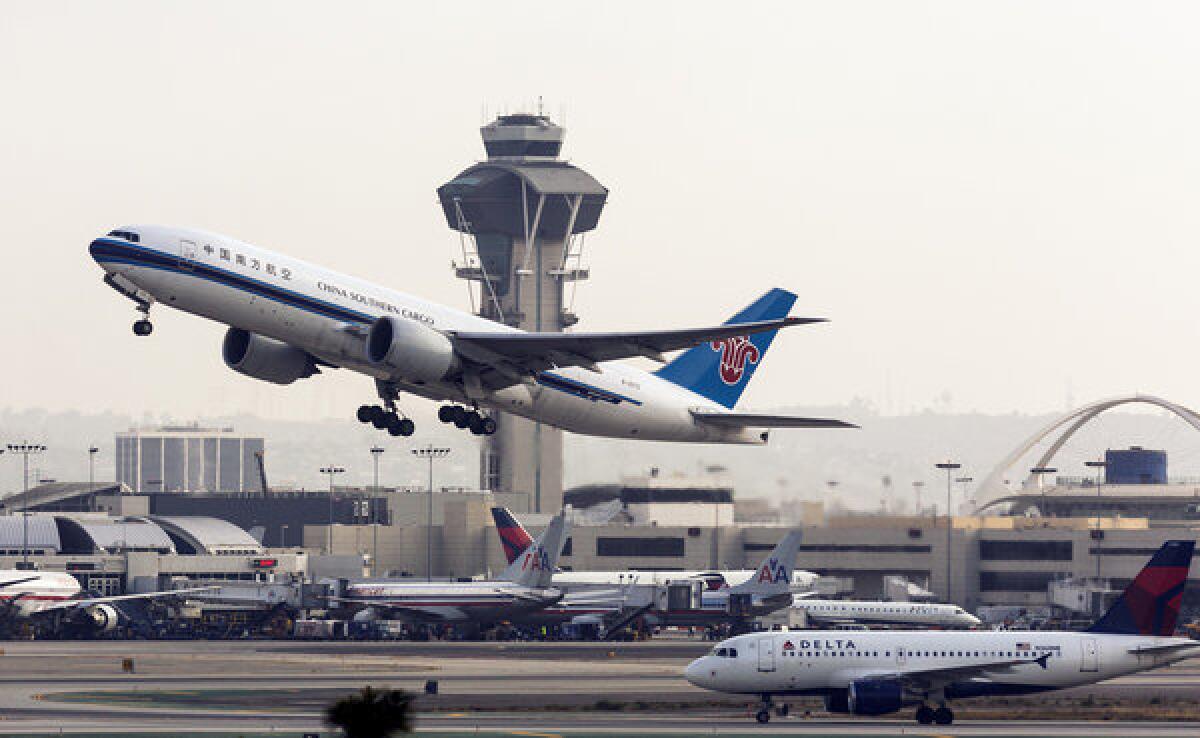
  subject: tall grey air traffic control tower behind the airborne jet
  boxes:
[438,114,608,512]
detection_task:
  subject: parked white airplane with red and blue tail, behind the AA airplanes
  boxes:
[492,508,820,593]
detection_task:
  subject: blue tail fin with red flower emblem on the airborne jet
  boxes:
[655,288,796,409]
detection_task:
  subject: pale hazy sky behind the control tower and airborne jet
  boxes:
[0,0,1200,419]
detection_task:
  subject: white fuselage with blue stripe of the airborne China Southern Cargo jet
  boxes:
[90,226,787,444]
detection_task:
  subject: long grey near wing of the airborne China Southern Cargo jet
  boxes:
[450,317,824,372]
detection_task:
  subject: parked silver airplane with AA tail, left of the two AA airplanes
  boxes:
[334,512,568,623]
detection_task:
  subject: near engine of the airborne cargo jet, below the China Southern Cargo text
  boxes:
[367,316,458,384]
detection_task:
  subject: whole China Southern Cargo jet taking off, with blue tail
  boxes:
[90,226,853,444]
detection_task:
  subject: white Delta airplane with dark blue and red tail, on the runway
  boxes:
[684,540,1200,725]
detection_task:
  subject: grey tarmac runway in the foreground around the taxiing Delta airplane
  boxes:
[0,640,1200,737]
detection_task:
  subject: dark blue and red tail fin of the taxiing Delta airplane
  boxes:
[1087,541,1195,636]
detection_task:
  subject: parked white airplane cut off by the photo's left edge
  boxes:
[0,569,211,632]
